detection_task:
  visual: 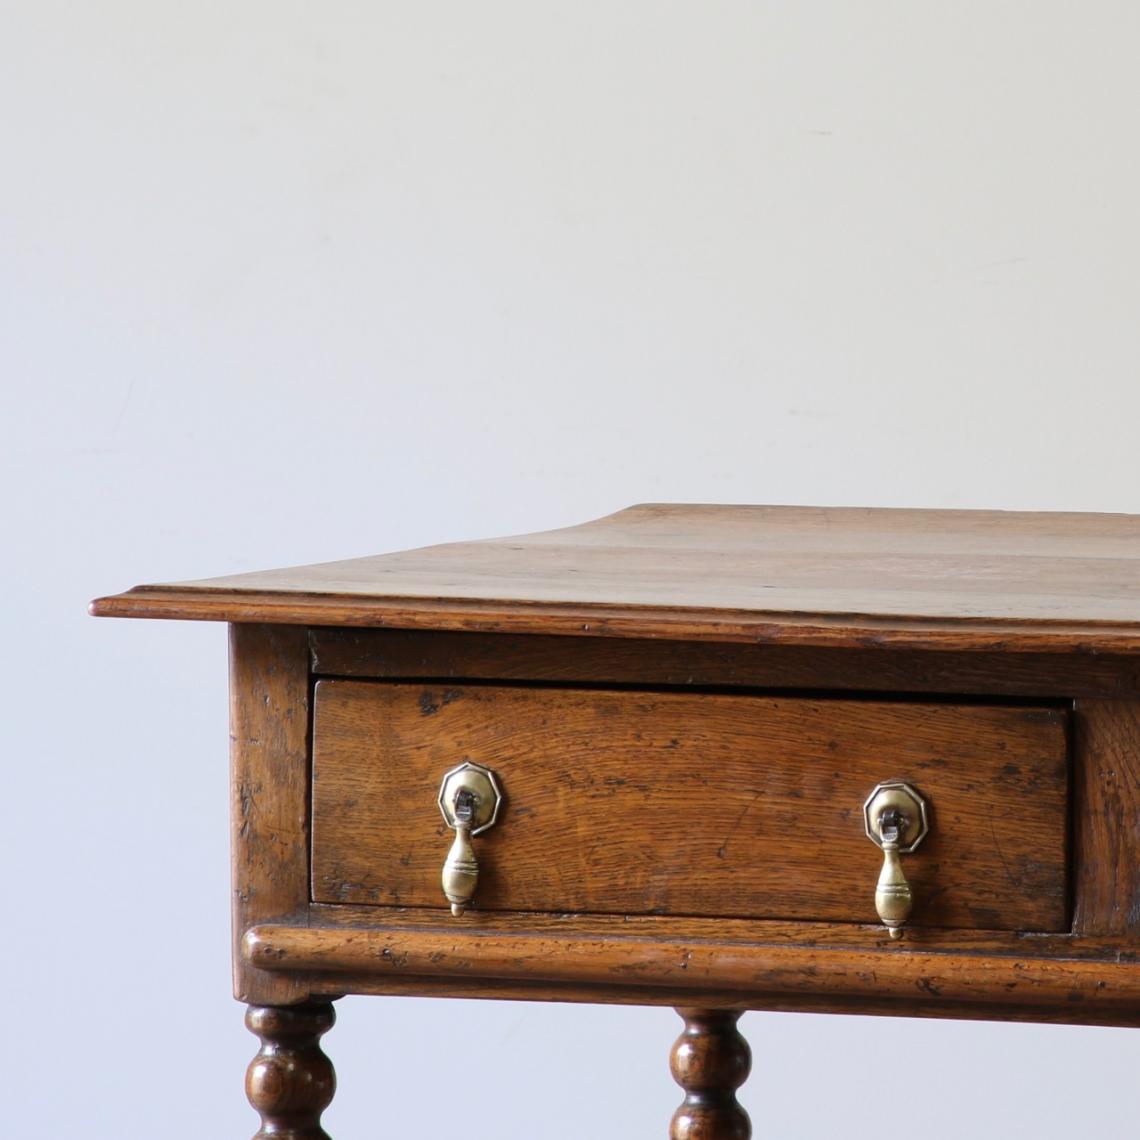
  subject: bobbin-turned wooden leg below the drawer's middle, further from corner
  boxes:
[669,1009,752,1140]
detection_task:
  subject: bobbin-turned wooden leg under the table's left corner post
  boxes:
[245,1001,336,1140]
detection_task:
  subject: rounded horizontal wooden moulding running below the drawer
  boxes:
[243,917,1140,1015]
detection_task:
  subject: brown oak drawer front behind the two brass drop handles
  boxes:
[312,681,1068,931]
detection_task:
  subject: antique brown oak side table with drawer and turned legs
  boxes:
[92,505,1140,1140]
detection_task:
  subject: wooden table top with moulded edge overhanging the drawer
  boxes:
[91,504,1140,652]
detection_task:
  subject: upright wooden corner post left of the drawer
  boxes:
[230,626,309,1004]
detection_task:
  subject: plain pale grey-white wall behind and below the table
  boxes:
[0,0,1140,1140]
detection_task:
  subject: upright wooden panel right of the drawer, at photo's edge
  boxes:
[1073,701,1140,937]
